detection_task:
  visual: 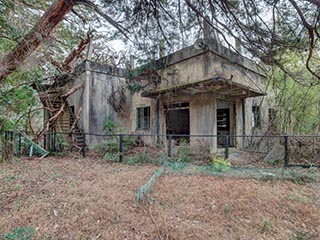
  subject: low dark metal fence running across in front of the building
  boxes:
[0,132,320,167]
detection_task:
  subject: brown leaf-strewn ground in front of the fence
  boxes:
[0,158,320,240]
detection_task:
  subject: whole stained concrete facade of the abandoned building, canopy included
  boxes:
[68,40,269,151]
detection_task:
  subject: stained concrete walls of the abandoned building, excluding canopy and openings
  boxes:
[69,42,268,150]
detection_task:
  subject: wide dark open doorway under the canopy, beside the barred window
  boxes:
[164,103,190,139]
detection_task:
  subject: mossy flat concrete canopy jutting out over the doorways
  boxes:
[141,77,267,98]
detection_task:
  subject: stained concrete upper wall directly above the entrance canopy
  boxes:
[158,39,265,91]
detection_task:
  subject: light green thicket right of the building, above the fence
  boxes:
[269,52,320,135]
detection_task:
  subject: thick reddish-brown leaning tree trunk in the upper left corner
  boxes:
[0,0,76,83]
